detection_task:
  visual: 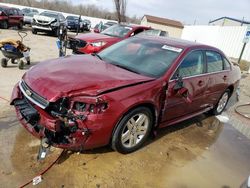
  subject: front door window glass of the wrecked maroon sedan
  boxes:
[175,51,204,77]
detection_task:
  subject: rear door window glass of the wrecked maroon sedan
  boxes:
[206,51,223,73]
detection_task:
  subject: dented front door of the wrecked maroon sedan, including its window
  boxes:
[163,50,209,121]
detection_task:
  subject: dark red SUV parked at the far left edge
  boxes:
[0,5,23,29]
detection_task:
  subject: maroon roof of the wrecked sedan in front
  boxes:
[134,35,221,52]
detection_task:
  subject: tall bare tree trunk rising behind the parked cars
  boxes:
[114,0,127,23]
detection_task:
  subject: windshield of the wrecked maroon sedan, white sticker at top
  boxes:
[98,37,182,78]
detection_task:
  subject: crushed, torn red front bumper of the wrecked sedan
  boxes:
[11,84,115,150]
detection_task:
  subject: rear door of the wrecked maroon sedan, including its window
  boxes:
[206,50,231,105]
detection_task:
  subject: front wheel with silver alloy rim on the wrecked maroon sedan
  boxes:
[111,107,153,154]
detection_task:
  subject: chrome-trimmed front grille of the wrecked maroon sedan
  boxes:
[19,81,49,109]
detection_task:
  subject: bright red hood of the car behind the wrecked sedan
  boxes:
[75,33,118,42]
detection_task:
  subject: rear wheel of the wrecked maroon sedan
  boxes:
[211,89,231,115]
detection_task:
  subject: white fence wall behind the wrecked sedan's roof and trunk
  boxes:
[181,26,250,61]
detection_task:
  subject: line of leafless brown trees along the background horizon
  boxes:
[0,0,140,23]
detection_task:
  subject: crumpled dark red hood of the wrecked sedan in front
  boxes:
[23,55,153,102]
